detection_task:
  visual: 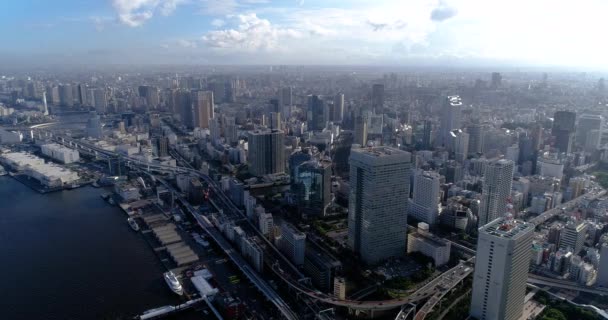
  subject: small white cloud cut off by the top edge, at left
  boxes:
[112,0,186,27]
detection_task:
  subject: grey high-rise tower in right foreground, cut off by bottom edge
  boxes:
[471,217,534,320]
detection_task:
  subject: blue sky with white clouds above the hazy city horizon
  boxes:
[0,0,608,70]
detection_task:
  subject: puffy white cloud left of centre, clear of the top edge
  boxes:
[202,13,300,52]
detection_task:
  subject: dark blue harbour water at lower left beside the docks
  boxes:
[0,176,184,320]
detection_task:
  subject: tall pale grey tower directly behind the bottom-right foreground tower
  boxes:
[479,159,514,226]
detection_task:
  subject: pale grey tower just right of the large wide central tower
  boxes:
[408,171,441,225]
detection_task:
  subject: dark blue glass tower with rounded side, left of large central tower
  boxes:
[293,160,331,216]
